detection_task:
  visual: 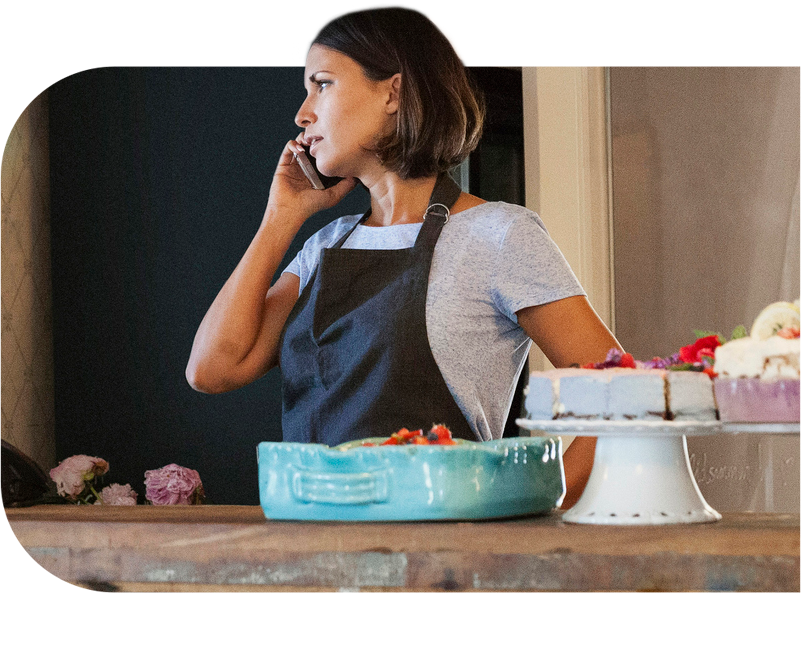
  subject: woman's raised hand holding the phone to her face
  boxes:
[267,132,356,228]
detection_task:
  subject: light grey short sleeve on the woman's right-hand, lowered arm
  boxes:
[492,208,586,322]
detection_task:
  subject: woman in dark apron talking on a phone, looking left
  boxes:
[187,9,619,500]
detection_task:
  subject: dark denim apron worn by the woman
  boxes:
[279,174,476,445]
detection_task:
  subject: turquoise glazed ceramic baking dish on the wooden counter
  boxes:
[258,437,565,521]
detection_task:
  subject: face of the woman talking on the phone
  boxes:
[295,44,400,177]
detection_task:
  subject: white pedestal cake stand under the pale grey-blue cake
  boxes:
[516,418,799,525]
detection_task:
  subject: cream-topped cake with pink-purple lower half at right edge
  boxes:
[714,302,801,422]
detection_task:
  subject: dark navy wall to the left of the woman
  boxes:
[49,67,367,504]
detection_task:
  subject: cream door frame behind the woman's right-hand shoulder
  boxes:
[523,67,615,371]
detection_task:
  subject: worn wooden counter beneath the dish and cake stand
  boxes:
[6,505,799,592]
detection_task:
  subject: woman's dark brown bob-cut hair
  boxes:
[313,8,485,179]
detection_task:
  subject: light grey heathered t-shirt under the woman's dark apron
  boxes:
[285,202,585,441]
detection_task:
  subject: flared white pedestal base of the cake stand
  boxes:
[562,433,720,525]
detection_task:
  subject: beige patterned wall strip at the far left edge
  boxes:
[0,95,55,470]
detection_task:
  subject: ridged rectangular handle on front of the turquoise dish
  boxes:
[290,469,389,505]
